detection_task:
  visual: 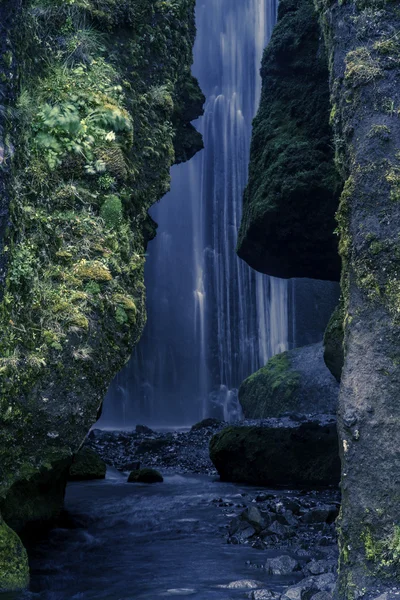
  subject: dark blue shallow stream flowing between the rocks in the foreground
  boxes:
[14,471,304,600]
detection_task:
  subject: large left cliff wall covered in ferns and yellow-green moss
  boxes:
[0,0,202,588]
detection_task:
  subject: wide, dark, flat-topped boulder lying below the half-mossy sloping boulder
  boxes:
[210,417,340,487]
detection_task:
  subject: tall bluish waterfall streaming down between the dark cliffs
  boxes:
[102,0,290,426]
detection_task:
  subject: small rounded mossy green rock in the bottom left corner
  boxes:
[0,517,29,593]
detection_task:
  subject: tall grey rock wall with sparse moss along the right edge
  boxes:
[317,0,400,599]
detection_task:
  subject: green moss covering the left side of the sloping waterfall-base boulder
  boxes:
[239,352,300,419]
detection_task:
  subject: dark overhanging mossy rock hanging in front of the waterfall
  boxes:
[237,0,341,280]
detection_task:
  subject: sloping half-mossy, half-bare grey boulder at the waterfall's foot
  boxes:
[239,343,339,419]
